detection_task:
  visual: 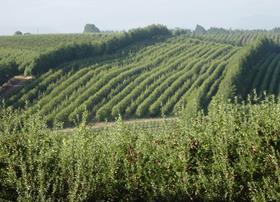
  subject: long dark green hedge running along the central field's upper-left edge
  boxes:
[25,25,170,74]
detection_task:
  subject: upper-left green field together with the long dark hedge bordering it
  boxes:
[0,25,171,84]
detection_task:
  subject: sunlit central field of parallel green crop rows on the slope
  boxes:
[1,37,238,122]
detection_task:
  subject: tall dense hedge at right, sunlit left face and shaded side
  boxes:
[215,38,279,98]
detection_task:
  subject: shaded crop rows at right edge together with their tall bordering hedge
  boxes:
[218,38,280,98]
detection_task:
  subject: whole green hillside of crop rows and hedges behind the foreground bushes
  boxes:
[0,25,280,125]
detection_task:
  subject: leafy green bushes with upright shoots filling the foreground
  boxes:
[0,99,280,201]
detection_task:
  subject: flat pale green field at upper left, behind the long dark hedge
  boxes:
[0,33,115,85]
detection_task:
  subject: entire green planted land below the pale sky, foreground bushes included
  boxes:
[0,25,280,201]
